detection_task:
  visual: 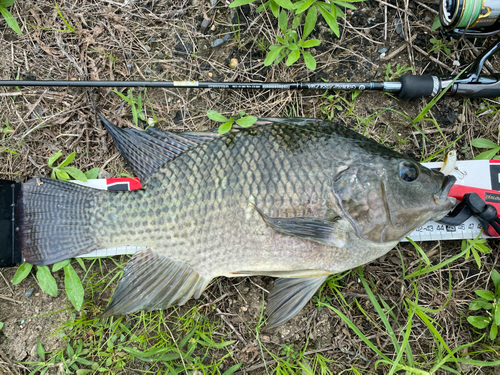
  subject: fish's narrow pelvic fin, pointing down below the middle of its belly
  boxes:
[266,275,328,328]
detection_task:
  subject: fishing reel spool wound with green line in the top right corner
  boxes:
[439,0,500,38]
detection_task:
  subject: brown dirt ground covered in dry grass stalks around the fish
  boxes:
[0,0,500,374]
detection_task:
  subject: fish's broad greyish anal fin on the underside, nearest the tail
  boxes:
[99,248,211,318]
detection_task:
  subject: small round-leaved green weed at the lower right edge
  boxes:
[467,269,500,340]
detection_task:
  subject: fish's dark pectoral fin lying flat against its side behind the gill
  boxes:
[253,206,344,247]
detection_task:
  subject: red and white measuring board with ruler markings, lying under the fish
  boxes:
[72,160,500,257]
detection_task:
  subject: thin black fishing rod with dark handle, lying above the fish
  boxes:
[0,41,500,99]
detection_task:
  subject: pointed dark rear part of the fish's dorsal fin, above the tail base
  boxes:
[99,114,221,183]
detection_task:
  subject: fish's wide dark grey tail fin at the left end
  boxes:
[16,177,100,266]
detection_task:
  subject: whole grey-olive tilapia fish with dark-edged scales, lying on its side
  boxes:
[17,117,455,327]
